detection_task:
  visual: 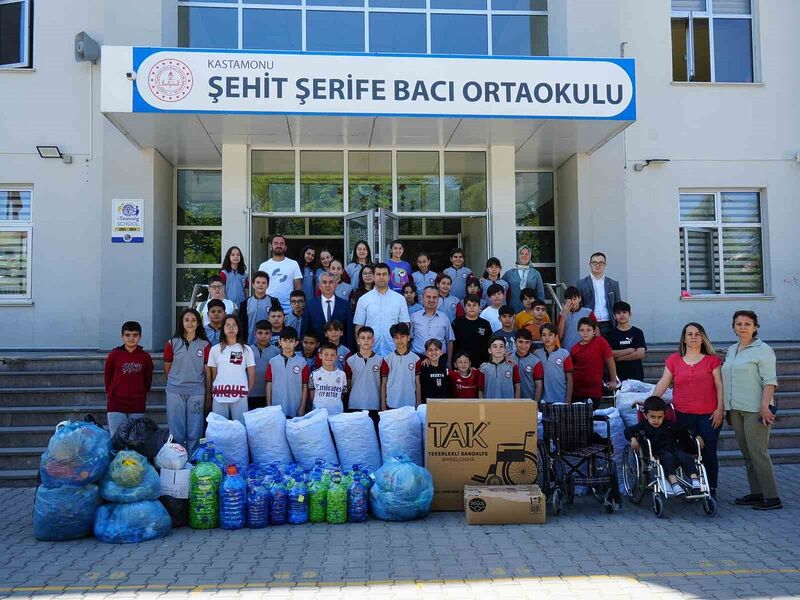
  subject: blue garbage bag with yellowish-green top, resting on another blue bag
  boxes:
[100,450,161,503]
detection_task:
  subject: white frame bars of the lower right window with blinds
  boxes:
[677,188,770,298]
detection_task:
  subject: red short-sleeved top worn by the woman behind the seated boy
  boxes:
[666,352,722,415]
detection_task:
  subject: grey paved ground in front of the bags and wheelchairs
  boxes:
[0,465,800,600]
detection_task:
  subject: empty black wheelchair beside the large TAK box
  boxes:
[539,402,622,515]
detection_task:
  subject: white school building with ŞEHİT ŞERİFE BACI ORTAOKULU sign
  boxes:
[0,0,800,350]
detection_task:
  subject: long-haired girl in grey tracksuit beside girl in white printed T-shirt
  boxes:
[164,308,211,456]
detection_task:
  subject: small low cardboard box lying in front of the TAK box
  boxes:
[464,485,547,525]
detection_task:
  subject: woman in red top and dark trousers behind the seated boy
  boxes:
[653,323,725,497]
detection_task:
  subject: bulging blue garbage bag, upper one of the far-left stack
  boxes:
[39,421,111,487]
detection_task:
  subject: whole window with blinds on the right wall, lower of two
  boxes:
[679,191,764,295]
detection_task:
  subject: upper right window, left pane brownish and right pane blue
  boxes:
[671,0,754,83]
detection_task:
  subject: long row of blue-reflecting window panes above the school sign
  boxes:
[178,0,548,56]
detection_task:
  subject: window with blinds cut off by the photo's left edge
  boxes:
[0,188,33,302]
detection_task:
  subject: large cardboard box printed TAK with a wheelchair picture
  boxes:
[425,399,538,510]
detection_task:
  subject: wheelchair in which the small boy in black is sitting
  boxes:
[622,407,718,518]
